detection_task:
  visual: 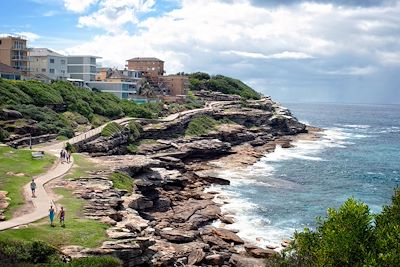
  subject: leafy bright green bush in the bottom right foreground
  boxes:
[267,188,400,267]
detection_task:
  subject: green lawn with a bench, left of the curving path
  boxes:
[0,146,56,219]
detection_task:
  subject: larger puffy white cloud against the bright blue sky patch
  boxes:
[78,0,155,32]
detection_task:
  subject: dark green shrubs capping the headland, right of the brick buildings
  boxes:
[189,72,261,99]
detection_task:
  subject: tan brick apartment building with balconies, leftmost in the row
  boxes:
[0,35,29,76]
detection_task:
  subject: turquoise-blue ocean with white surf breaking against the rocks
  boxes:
[211,103,400,249]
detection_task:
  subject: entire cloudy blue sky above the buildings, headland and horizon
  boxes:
[0,0,400,104]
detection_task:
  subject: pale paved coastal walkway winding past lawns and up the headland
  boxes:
[0,101,227,231]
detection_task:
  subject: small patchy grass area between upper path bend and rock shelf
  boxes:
[64,154,105,180]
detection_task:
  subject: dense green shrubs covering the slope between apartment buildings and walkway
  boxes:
[0,79,163,141]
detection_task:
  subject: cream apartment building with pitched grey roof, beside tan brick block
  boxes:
[28,48,69,80]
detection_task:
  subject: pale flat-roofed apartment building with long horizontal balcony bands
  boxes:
[67,55,100,81]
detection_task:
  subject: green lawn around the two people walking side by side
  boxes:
[0,188,108,248]
